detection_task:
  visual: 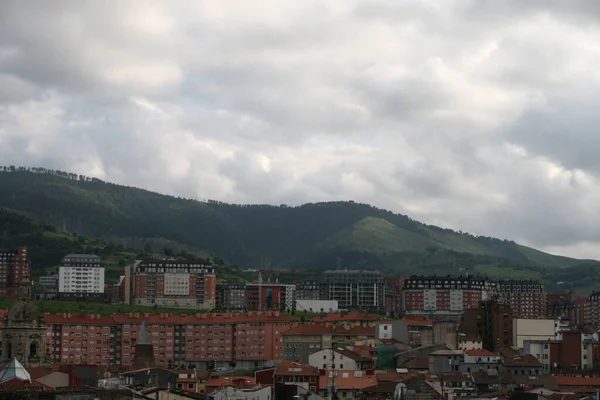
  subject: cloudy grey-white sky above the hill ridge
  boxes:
[0,0,600,259]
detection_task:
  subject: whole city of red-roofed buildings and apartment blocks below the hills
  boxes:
[0,247,600,400]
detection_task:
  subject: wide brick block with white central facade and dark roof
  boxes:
[125,259,217,310]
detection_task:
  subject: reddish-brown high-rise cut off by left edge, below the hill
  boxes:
[0,247,31,299]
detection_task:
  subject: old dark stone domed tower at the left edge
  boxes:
[0,275,48,367]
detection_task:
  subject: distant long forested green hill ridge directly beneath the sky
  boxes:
[0,167,583,273]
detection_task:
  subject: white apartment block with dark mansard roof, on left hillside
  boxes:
[58,254,104,301]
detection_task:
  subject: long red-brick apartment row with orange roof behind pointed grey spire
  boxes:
[45,311,292,368]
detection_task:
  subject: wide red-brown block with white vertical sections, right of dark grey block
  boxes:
[401,275,494,320]
